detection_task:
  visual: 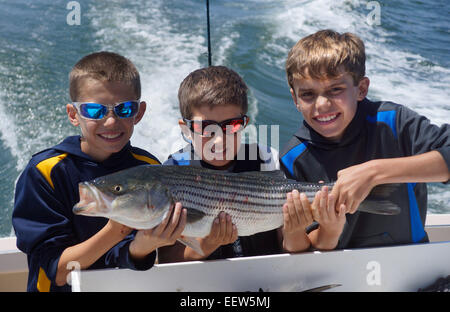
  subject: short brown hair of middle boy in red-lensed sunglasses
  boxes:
[178,66,248,119]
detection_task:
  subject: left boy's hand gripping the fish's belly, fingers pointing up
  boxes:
[130,203,187,259]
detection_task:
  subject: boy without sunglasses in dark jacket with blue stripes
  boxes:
[280,30,450,249]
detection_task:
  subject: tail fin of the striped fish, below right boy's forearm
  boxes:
[358,183,401,215]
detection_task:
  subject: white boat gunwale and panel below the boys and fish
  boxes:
[0,214,450,291]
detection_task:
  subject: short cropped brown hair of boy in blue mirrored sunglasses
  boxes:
[69,51,141,102]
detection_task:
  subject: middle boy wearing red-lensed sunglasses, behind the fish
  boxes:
[158,66,309,263]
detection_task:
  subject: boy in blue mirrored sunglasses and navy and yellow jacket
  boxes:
[12,52,186,291]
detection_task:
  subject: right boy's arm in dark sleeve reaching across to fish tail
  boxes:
[332,105,450,213]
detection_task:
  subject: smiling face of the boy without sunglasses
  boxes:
[291,73,370,140]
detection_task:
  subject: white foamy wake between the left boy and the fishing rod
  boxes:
[89,1,206,161]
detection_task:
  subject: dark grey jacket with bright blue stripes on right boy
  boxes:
[280,99,450,248]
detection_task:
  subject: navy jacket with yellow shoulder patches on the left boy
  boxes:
[12,136,159,291]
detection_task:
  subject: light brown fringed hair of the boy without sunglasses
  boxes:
[286,29,366,91]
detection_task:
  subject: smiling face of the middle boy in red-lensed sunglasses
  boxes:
[179,105,242,169]
